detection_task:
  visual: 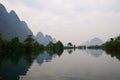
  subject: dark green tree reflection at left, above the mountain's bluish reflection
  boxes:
[0,49,41,64]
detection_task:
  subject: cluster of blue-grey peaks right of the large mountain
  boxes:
[36,32,56,46]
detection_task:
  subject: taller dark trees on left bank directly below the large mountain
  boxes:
[0,34,44,52]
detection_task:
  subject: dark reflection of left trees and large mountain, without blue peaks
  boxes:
[0,50,42,80]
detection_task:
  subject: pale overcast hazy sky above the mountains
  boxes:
[0,0,120,45]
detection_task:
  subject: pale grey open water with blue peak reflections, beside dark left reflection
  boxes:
[19,50,120,80]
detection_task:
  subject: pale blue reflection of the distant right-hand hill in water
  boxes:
[85,49,103,57]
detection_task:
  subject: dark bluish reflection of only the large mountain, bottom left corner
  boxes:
[0,59,31,80]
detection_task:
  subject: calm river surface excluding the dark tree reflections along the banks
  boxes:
[0,50,120,80]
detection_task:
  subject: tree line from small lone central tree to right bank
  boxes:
[64,35,120,52]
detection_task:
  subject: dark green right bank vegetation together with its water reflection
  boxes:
[84,36,120,60]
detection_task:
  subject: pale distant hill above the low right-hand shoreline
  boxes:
[84,37,103,46]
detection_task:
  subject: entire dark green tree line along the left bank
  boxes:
[0,34,63,54]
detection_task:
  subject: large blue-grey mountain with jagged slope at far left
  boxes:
[0,4,33,41]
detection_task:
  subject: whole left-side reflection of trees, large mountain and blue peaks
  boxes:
[0,50,62,80]
